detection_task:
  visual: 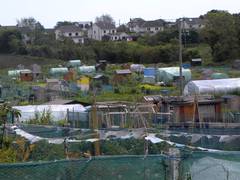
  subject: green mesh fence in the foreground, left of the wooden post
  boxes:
[0,156,166,180]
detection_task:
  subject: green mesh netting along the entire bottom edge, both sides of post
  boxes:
[0,152,240,180]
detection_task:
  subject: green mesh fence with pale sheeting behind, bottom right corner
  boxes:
[179,151,240,180]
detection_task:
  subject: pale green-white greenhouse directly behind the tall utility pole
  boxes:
[156,67,192,84]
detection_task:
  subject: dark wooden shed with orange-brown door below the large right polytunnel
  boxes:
[160,96,223,126]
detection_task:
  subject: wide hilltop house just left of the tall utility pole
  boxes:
[128,18,166,34]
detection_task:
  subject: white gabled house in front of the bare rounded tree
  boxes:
[88,22,117,41]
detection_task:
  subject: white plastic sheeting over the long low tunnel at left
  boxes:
[13,104,86,121]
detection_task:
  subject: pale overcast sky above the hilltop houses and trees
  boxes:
[0,0,240,28]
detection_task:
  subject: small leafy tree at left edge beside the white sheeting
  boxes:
[0,103,21,149]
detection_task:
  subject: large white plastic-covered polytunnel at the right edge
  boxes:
[184,78,240,95]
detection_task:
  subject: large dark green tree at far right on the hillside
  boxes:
[201,10,239,62]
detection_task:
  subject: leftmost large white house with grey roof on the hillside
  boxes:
[55,25,87,44]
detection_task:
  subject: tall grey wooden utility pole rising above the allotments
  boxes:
[179,19,183,96]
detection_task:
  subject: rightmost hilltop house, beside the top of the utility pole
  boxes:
[176,18,205,30]
